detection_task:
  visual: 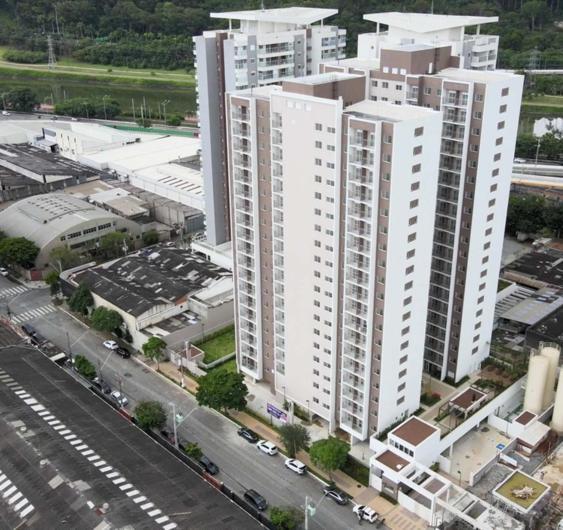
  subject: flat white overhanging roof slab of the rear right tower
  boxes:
[364,11,498,33]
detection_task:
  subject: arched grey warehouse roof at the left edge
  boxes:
[0,193,125,247]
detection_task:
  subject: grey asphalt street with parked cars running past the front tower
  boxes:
[0,277,367,530]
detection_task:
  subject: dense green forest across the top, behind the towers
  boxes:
[0,0,563,69]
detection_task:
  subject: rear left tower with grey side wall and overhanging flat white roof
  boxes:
[194,7,346,245]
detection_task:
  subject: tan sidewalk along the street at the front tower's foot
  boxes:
[159,362,368,499]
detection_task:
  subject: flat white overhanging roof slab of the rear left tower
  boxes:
[209,7,338,26]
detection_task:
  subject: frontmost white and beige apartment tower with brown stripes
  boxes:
[227,73,442,440]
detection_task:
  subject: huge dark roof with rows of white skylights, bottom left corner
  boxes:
[0,346,259,530]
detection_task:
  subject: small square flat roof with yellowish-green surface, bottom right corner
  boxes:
[493,471,549,514]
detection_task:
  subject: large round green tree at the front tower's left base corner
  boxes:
[196,368,248,412]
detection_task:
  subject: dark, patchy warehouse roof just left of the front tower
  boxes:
[72,247,231,317]
